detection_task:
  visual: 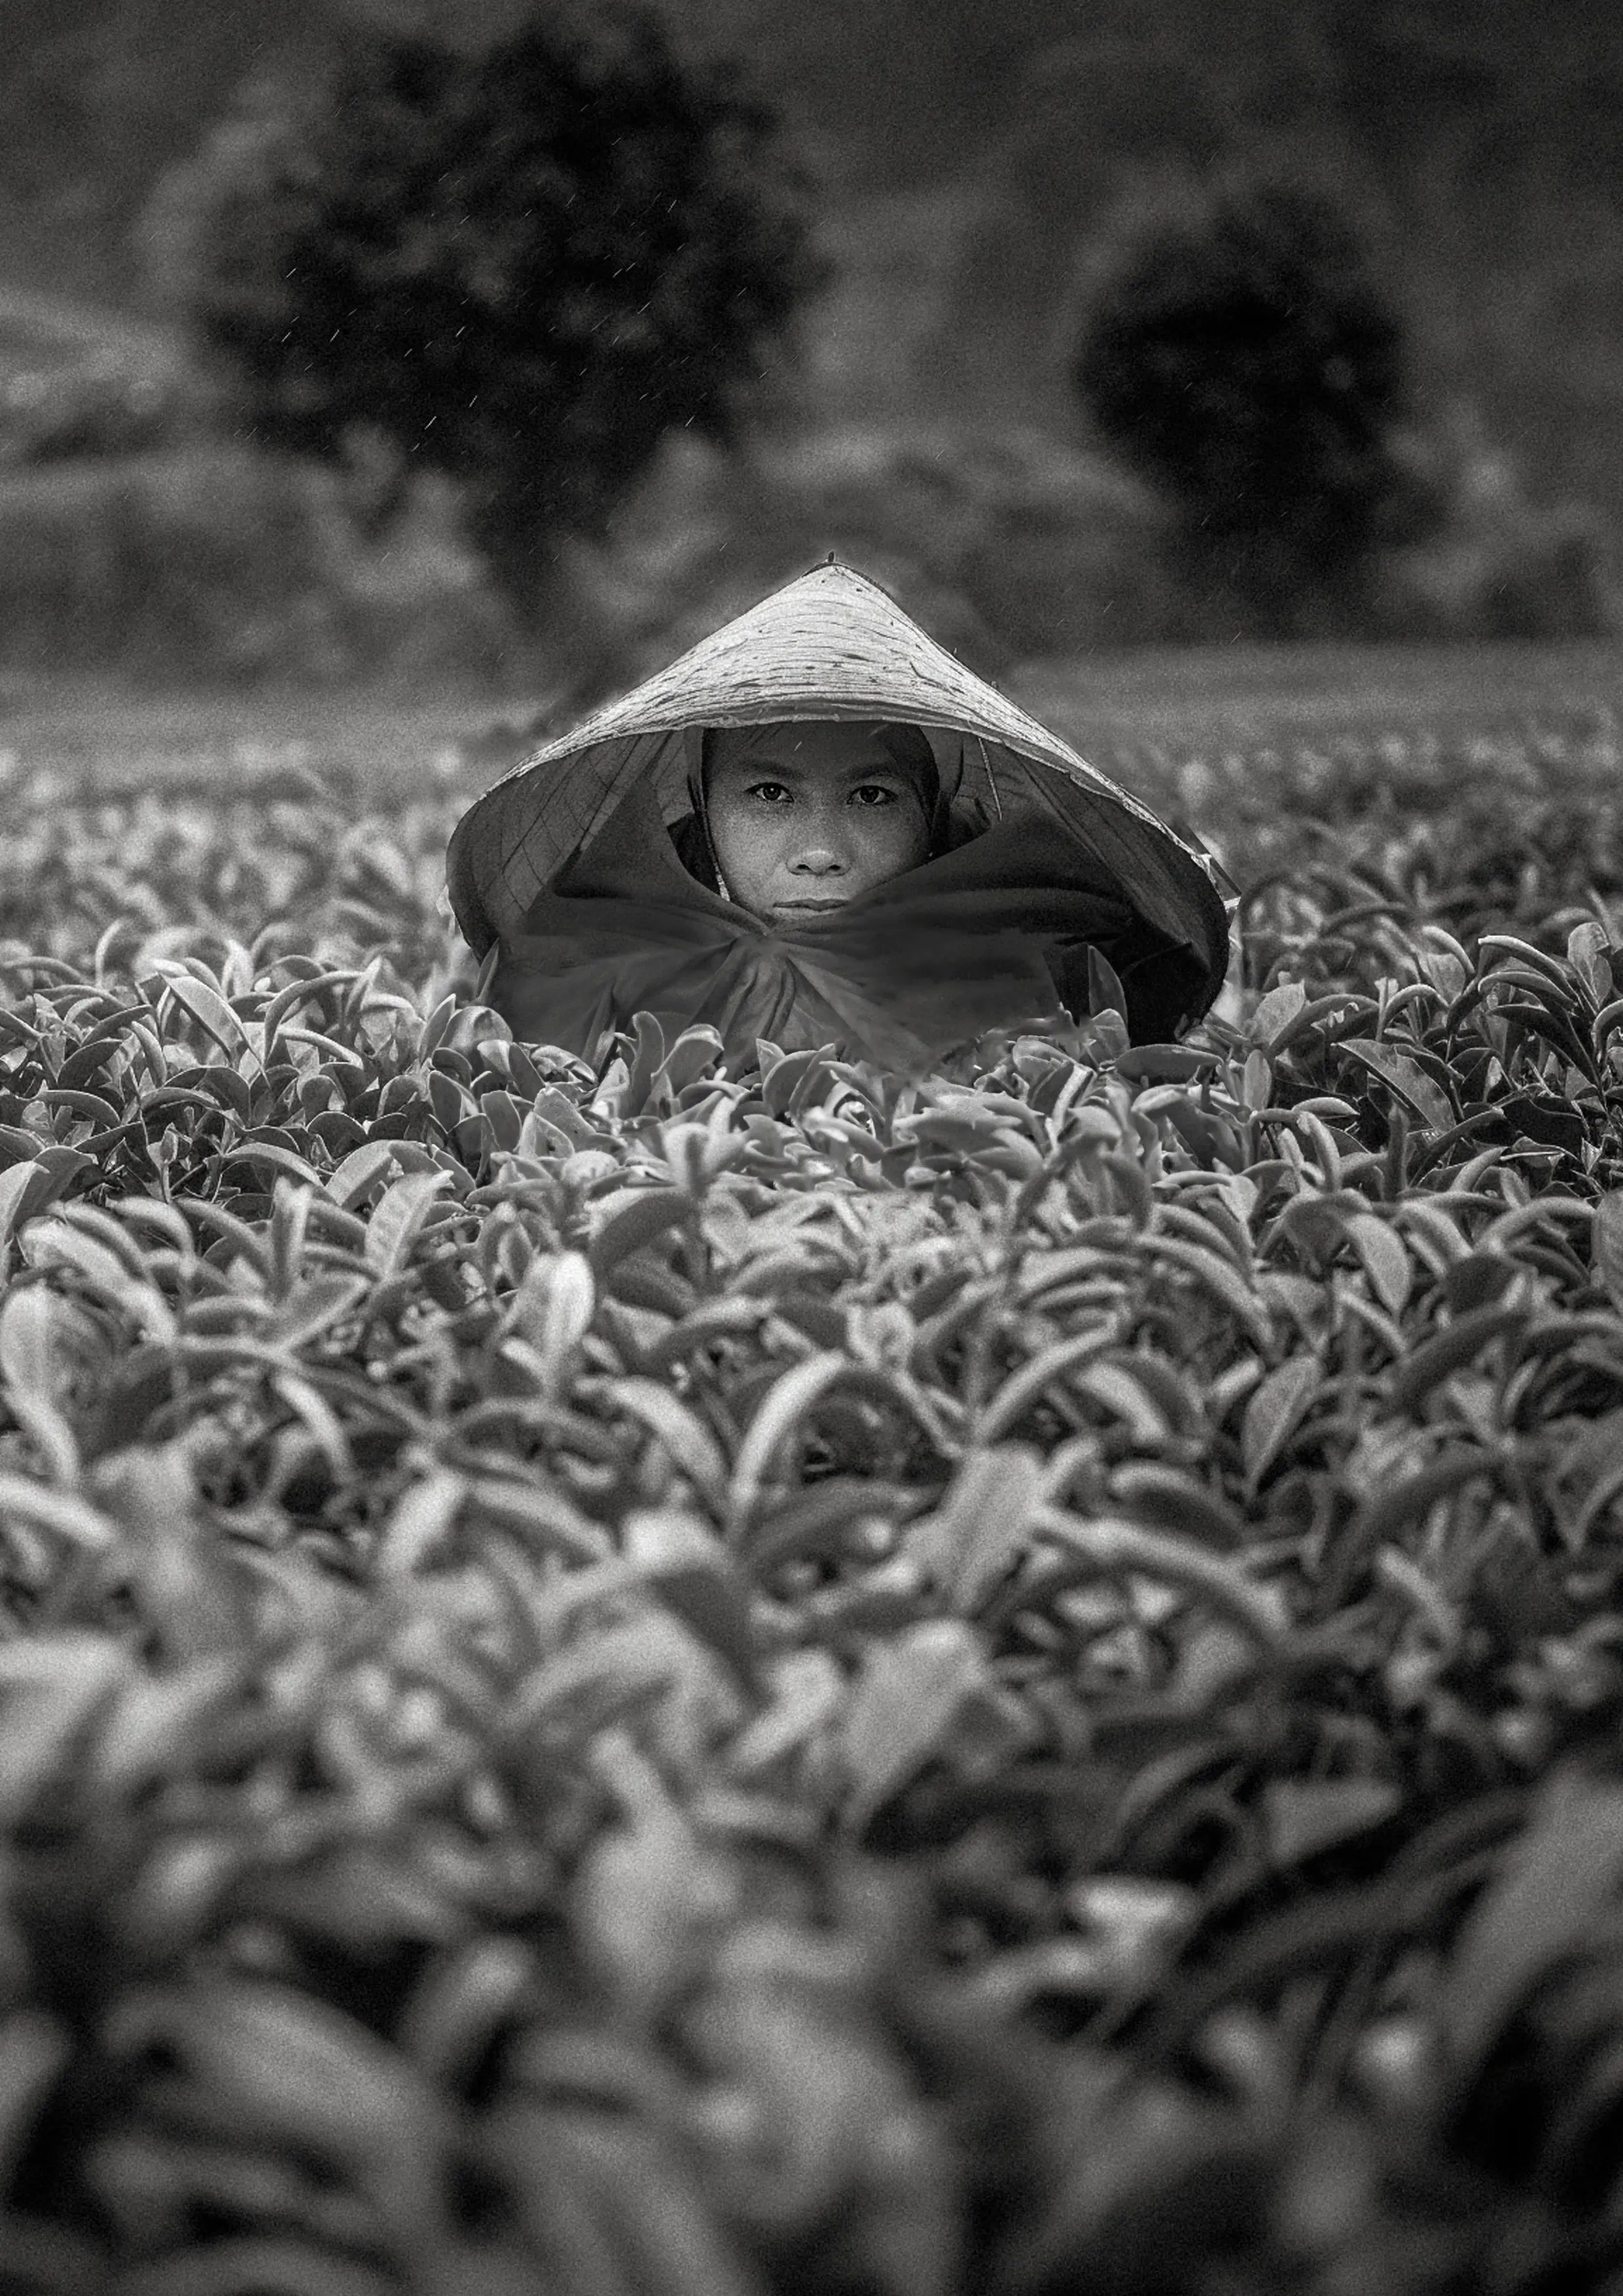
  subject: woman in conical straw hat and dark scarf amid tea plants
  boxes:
[450,562,1228,1072]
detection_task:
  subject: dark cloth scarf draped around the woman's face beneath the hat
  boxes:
[491,707,1201,1075]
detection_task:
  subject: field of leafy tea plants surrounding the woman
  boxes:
[0,684,1623,2296]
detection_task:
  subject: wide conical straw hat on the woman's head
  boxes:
[448,560,1228,1008]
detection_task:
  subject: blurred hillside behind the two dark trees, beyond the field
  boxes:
[0,0,1623,684]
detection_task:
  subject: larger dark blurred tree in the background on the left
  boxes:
[190,0,819,600]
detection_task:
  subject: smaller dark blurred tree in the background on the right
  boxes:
[1072,186,1442,634]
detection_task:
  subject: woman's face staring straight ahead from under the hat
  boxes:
[705,723,930,923]
